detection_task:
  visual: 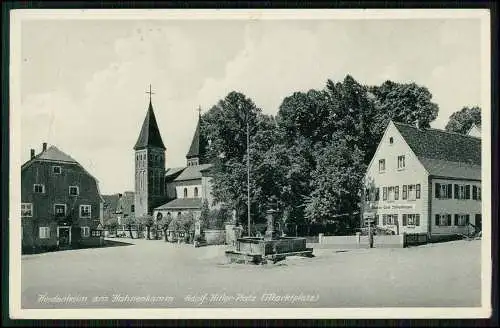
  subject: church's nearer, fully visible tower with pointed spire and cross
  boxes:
[134,86,166,217]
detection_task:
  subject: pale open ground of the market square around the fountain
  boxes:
[22,239,481,308]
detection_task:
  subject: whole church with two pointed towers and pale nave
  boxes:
[134,93,213,224]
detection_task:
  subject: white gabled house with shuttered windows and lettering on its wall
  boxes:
[364,121,482,238]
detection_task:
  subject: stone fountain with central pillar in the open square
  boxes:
[226,208,314,264]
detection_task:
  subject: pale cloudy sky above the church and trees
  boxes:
[16,13,482,194]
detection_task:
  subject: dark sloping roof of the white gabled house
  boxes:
[394,122,481,180]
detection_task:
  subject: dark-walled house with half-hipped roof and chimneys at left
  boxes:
[21,143,103,251]
